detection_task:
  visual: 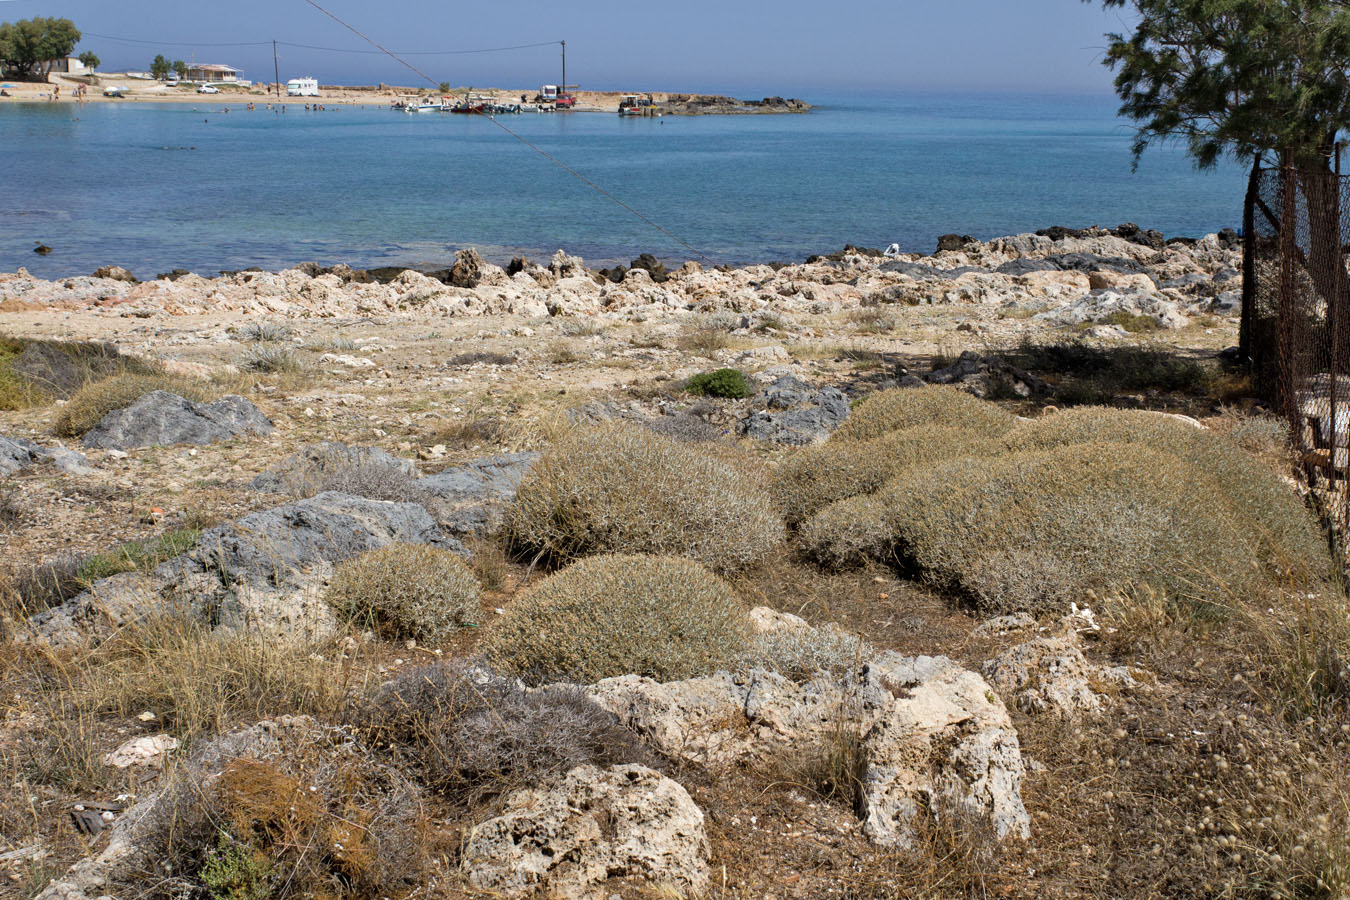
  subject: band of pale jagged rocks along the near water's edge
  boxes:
[0,225,1241,337]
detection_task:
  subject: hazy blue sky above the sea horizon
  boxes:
[0,0,1125,99]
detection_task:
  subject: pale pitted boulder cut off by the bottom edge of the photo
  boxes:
[464,765,709,900]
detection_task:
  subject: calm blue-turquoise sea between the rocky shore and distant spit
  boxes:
[0,93,1245,278]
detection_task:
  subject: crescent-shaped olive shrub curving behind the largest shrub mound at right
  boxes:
[1006,406,1331,584]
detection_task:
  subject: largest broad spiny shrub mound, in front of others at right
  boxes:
[876,444,1261,620]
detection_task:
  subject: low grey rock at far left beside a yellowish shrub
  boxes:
[84,391,273,449]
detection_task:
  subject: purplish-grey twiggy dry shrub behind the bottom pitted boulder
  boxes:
[359,664,652,804]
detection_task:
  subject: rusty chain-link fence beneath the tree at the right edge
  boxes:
[1242,166,1350,533]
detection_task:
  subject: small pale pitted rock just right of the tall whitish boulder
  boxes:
[984,633,1142,718]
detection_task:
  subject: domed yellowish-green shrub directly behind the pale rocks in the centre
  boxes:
[483,556,751,684]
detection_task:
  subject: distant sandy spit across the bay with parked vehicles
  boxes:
[0,74,813,116]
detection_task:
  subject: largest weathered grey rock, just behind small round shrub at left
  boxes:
[184,491,464,586]
